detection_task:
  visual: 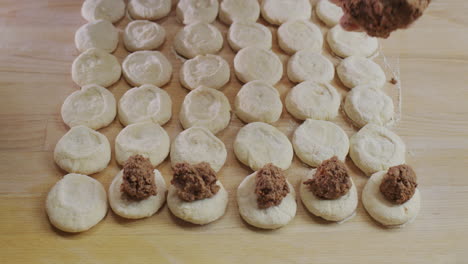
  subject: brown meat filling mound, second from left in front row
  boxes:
[171,162,219,202]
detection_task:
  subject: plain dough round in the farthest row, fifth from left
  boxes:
[261,0,312,25]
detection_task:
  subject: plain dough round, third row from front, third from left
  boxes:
[179,86,231,134]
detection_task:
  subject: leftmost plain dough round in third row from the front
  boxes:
[61,84,117,130]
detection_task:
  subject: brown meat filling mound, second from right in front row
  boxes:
[304,156,351,200]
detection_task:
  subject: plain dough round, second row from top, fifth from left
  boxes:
[278,20,323,55]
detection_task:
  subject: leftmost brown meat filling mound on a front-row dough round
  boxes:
[120,155,157,200]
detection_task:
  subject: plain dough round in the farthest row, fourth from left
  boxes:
[219,0,260,25]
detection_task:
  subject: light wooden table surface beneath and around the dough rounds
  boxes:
[0,0,468,263]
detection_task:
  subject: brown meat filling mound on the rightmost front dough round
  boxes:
[380,165,418,204]
